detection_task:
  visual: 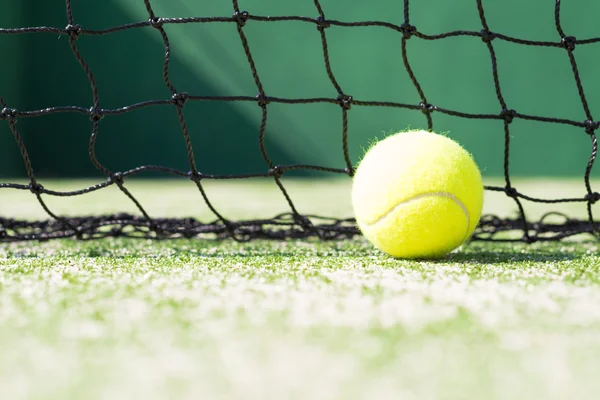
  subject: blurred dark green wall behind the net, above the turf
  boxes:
[0,0,600,177]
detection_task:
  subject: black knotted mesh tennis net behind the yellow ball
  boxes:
[0,0,600,243]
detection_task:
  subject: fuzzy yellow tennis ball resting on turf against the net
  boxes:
[351,130,483,259]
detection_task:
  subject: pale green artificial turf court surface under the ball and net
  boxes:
[0,182,600,400]
